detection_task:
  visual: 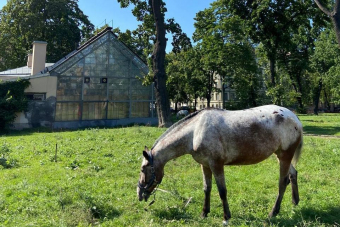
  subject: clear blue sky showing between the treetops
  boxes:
[0,0,214,52]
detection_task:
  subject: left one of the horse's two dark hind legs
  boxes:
[269,160,290,218]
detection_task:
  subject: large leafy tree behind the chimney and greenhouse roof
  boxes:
[0,0,93,69]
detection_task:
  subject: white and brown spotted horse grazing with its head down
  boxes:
[137,105,302,224]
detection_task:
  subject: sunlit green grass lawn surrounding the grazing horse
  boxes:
[0,115,340,226]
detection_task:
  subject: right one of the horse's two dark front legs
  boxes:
[212,165,231,223]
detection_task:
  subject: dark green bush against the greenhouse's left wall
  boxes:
[0,80,30,131]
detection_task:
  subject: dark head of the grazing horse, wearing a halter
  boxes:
[137,147,160,201]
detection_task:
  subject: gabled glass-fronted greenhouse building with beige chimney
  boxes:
[0,28,157,128]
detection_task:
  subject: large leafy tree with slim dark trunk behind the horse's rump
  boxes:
[220,0,324,104]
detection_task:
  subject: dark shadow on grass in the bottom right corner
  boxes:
[270,206,340,226]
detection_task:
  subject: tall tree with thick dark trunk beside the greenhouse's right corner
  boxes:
[117,0,189,127]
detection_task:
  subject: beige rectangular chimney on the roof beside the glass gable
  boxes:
[31,41,47,75]
